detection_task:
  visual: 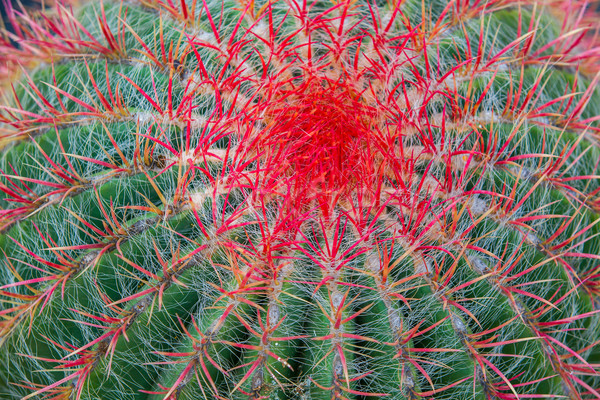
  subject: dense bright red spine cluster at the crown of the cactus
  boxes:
[259,77,377,206]
